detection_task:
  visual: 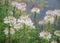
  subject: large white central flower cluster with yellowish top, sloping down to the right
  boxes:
[18,15,34,27]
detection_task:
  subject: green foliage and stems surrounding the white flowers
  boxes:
[0,0,60,43]
